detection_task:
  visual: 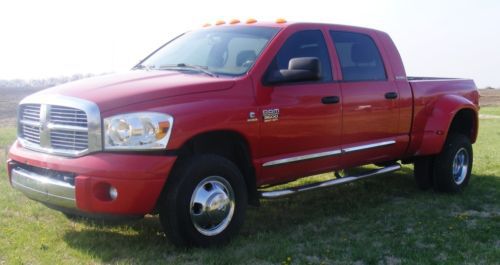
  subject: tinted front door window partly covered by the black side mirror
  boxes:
[267,30,332,81]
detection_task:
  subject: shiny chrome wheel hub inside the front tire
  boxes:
[190,176,235,236]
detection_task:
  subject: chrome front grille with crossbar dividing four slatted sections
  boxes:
[18,96,101,156]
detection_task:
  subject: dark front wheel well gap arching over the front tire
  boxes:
[178,131,259,206]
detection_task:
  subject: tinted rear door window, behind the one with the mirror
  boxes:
[330,31,387,81]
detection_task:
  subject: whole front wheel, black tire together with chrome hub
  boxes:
[159,155,247,247]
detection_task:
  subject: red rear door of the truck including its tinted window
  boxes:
[330,30,406,167]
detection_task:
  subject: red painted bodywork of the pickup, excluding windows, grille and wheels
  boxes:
[9,23,478,214]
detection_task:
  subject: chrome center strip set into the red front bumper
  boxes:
[11,166,76,209]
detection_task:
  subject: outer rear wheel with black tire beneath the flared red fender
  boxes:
[434,134,473,192]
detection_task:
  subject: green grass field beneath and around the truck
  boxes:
[0,108,500,264]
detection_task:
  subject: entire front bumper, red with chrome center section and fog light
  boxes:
[8,142,176,215]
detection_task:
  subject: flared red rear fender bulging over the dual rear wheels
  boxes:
[410,95,478,156]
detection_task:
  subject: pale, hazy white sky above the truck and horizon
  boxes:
[0,0,500,88]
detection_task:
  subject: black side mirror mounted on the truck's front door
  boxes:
[267,57,321,84]
